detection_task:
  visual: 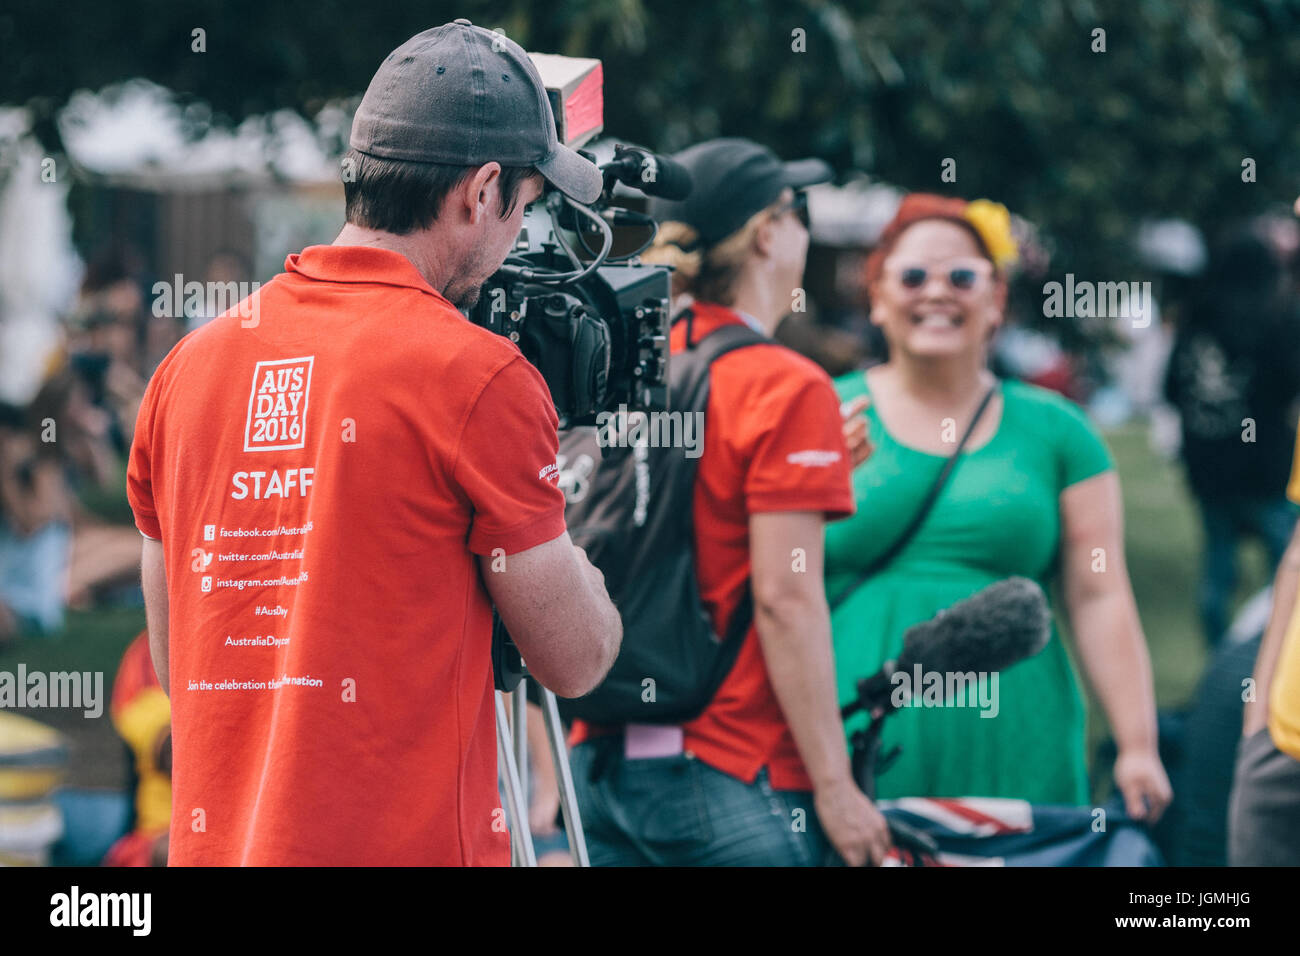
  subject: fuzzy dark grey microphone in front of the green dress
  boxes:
[840,578,1050,718]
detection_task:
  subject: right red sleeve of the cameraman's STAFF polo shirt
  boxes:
[452,356,564,555]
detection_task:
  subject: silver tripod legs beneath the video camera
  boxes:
[493,619,592,866]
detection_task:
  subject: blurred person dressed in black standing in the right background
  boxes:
[1165,232,1300,645]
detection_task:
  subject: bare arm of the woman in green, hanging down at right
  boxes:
[1061,471,1173,822]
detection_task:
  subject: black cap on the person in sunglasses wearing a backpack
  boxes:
[647,139,832,246]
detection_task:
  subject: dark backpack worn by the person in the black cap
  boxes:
[559,312,771,723]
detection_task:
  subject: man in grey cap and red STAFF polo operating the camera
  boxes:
[127,21,621,865]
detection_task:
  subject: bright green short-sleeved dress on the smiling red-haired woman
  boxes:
[826,372,1112,804]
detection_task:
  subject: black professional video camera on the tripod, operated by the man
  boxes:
[469,53,690,428]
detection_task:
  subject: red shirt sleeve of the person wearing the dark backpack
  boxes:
[742,352,854,520]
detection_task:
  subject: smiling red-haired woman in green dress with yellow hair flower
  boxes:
[826,195,1171,819]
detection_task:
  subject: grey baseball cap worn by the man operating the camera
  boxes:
[348,20,602,203]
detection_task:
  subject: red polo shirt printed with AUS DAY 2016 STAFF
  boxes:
[127,246,564,865]
